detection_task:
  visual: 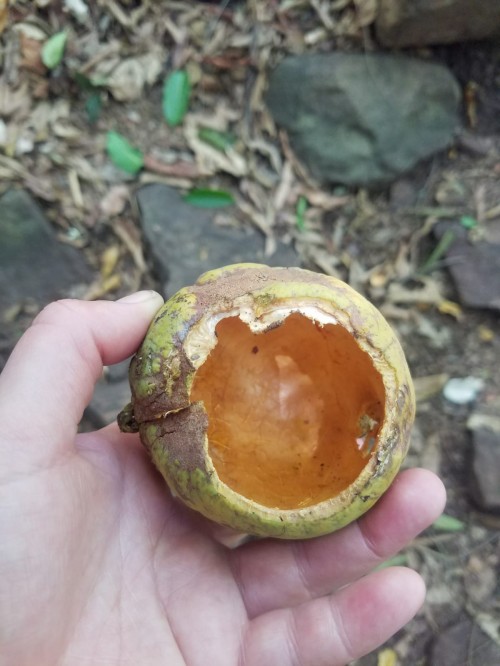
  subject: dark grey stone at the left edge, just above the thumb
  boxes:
[0,189,93,365]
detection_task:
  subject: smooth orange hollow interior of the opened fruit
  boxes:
[191,313,385,509]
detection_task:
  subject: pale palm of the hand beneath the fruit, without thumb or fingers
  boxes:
[8,428,252,665]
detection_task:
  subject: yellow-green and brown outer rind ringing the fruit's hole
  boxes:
[118,264,415,539]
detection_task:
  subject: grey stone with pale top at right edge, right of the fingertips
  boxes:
[468,414,500,512]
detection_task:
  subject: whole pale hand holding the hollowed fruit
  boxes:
[0,292,445,666]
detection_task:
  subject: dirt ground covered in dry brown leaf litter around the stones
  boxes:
[0,0,500,666]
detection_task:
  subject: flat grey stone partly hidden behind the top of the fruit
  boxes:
[137,184,300,296]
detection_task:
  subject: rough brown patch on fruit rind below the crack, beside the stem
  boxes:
[140,402,209,474]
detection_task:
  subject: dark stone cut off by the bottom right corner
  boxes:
[429,619,500,666]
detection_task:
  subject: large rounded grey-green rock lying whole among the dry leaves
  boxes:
[266,53,460,186]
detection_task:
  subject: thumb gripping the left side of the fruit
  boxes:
[0,291,163,469]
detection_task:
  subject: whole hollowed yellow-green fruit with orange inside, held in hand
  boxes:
[119,264,415,539]
